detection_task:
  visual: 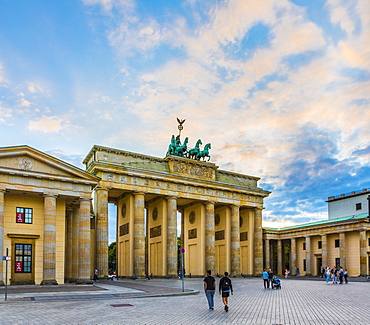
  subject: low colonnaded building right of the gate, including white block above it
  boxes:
[263,189,370,276]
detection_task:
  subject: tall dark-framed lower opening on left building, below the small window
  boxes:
[11,242,35,284]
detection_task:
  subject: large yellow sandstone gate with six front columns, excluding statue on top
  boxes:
[84,145,269,278]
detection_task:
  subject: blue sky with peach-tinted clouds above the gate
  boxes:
[0,0,370,239]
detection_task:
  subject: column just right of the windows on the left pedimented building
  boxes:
[40,194,58,285]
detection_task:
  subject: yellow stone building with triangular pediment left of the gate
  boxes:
[0,146,99,284]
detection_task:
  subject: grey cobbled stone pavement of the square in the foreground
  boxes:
[0,278,370,325]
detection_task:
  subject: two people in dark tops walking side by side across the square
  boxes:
[204,270,234,312]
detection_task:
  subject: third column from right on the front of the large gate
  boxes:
[206,202,214,274]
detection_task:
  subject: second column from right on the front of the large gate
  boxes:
[230,205,240,275]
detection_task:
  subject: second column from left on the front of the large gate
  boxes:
[134,193,145,278]
